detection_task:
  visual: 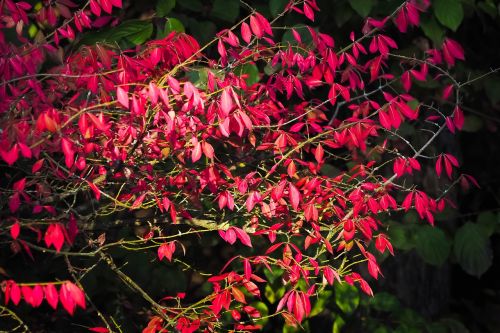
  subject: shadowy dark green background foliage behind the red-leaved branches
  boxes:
[0,0,500,333]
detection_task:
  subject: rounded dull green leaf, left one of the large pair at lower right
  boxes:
[415,225,451,266]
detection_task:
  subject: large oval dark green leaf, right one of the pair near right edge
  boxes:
[453,222,492,277]
